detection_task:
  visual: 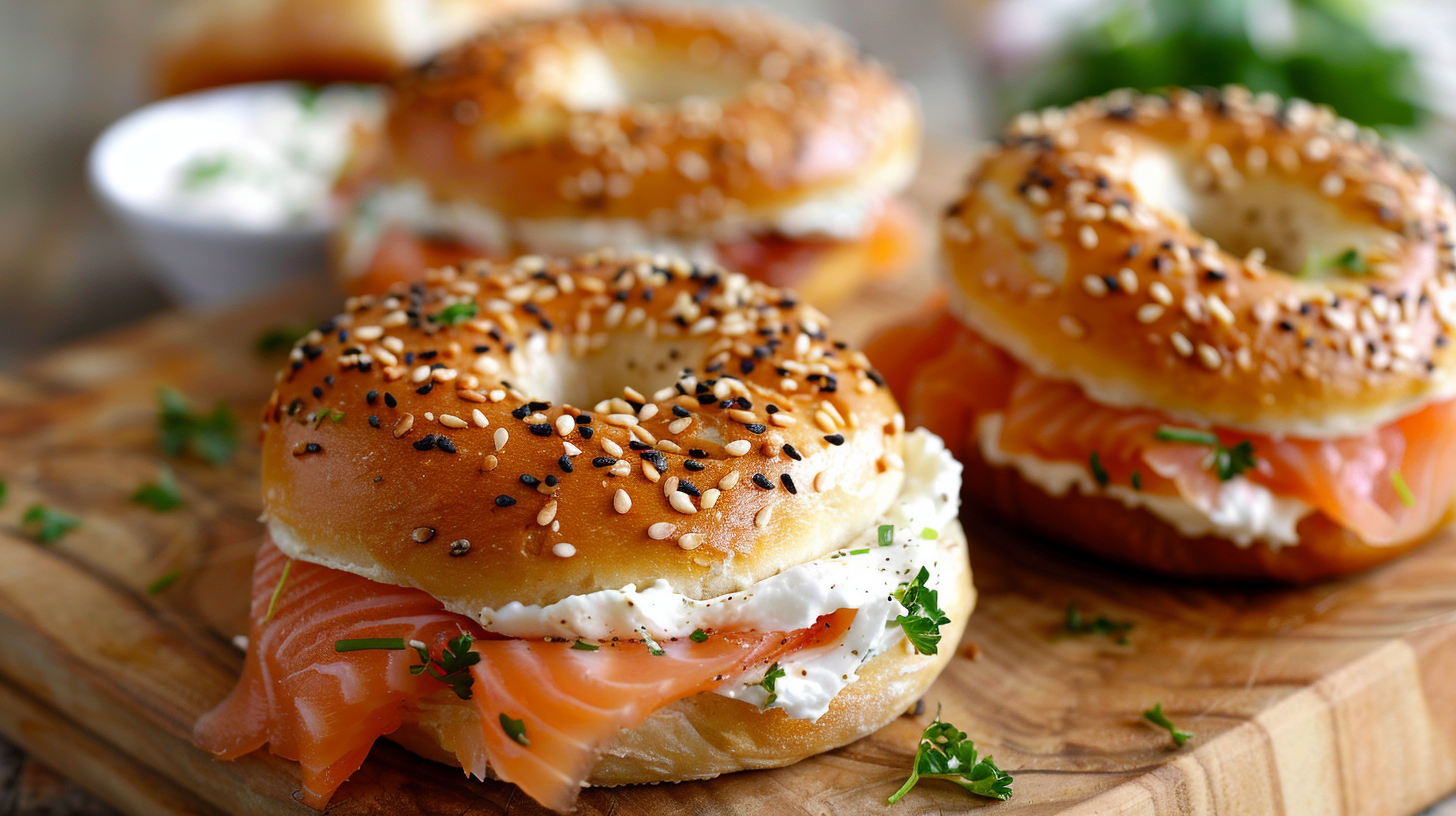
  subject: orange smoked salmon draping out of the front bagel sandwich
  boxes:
[194,541,855,810]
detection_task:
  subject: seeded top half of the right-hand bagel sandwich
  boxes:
[942,87,1456,437]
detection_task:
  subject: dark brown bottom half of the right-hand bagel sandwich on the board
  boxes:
[960,446,1428,583]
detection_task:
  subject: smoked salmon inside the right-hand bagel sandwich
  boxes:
[866,309,1456,546]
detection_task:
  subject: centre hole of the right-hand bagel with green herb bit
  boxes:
[1131,147,1386,275]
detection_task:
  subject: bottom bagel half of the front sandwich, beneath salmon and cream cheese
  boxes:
[389,523,976,787]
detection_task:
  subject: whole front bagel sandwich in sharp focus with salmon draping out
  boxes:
[195,254,974,810]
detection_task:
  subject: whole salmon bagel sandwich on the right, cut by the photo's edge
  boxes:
[871,89,1456,580]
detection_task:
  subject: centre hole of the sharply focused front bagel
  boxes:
[511,334,708,411]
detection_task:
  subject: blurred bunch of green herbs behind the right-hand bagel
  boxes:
[1006,0,1427,128]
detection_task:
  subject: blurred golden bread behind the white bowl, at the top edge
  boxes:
[154,0,562,96]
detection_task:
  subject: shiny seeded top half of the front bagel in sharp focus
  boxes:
[262,255,904,609]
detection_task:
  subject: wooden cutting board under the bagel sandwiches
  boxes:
[0,152,1456,816]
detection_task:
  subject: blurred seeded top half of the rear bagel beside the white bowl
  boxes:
[386,6,920,225]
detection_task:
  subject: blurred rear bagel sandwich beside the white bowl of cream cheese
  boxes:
[341,6,920,297]
